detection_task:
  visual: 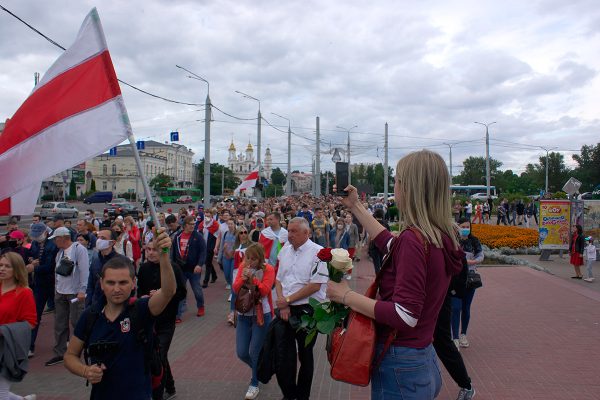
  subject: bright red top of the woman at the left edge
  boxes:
[0,282,37,328]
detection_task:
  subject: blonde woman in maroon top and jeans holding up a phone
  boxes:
[327,150,464,400]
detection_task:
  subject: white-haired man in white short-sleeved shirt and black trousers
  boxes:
[275,217,328,400]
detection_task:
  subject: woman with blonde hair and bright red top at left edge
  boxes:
[0,252,37,400]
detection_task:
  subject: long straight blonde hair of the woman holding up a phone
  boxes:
[395,150,458,248]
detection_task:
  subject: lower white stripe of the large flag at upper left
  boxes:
[0,96,127,200]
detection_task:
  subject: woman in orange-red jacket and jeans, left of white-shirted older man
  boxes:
[232,243,275,399]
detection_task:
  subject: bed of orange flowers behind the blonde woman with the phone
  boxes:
[471,224,539,249]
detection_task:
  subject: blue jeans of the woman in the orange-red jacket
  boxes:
[235,312,271,387]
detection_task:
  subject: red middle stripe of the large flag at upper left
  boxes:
[0,51,121,154]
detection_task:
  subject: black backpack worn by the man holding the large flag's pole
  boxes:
[82,298,164,389]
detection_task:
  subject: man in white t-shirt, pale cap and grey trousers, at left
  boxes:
[46,226,90,367]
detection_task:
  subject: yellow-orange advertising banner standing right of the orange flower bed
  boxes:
[539,200,571,250]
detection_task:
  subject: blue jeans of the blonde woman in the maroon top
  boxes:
[371,344,442,400]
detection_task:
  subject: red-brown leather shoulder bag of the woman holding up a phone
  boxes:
[327,228,429,386]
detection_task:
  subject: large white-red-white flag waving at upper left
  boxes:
[0,8,131,215]
